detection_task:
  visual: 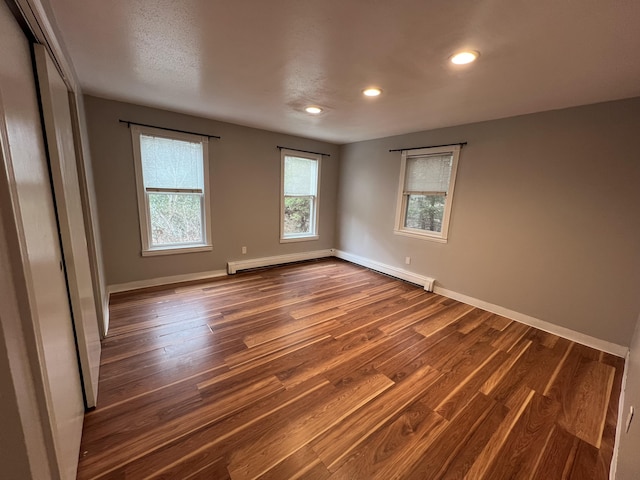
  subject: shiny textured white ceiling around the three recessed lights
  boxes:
[49,0,640,143]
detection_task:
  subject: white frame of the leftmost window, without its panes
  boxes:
[131,124,213,257]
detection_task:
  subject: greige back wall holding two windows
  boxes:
[85,96,339,285]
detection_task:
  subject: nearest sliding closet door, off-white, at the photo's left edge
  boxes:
[0,2,84,479]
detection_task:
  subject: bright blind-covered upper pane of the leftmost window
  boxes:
[140,135,204,189]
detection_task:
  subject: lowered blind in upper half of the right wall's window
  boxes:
[404,153,453,192]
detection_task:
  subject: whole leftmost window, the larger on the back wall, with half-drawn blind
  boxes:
[131,125,211,256]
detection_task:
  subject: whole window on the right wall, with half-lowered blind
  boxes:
[395,145,460,241]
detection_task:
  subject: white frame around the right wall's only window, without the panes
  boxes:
[393,145,460,243]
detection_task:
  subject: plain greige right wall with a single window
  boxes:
[336,98,640,346]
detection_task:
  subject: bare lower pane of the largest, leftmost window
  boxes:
[148,193,204,246]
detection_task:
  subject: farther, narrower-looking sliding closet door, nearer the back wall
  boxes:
[34,45,100,407]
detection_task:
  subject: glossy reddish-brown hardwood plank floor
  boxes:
[78,259,624,480]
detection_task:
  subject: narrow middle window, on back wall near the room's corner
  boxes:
[280,149,321,242]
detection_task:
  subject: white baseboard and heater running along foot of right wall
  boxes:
[335,250,629,358]
